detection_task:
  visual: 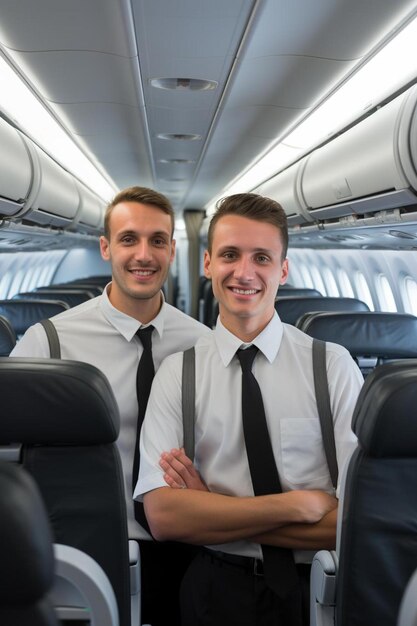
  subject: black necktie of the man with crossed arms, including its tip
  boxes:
[237,346,298,598]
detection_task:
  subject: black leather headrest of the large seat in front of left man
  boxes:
[0,357,120,445]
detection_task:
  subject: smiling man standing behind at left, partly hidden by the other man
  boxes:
[11,187,210,626]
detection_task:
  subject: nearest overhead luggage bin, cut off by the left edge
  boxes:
[0,118,33,216]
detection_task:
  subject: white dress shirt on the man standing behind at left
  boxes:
[10,287,211,539]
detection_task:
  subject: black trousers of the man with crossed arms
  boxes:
[180,550,310,626]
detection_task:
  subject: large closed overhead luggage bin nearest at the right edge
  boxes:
[301,87,417,220]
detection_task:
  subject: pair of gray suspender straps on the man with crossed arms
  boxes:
[182,339,338,489]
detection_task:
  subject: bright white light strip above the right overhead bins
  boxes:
[205,11,417,215]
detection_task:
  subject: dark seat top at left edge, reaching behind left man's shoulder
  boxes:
[0,297,69,339]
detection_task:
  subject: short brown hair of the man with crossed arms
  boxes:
[208,193,288,260]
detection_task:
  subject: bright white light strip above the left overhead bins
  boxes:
[0,51,117,202]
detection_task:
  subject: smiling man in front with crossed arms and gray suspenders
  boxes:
[135,194,363,626]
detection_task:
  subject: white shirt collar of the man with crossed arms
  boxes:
[214,311,283,367]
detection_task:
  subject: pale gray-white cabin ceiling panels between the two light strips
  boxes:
[0,0,416,217]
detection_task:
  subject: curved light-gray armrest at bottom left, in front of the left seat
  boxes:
[49,544,119,626]
